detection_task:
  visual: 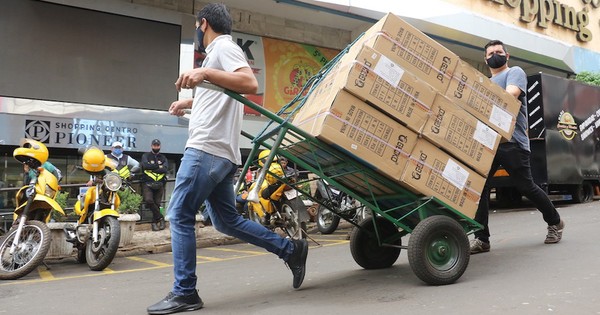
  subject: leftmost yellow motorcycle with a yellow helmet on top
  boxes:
[0,139,65,280]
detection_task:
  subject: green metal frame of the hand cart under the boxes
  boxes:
[202,83,483,251]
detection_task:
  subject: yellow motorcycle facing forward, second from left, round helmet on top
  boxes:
[64,147,122,271]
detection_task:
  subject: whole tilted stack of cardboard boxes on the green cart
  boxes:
[293,14,520,217]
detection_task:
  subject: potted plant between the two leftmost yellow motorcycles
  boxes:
[46,191,73,258]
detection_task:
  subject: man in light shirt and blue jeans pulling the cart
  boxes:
[147,3,308,314]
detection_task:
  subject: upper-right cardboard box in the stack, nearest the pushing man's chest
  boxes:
[445,60,521,139]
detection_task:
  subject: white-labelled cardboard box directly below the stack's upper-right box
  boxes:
[422,94,501,177]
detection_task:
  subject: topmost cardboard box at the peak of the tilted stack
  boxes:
[349,13,459,92]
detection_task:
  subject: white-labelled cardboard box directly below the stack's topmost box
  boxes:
[312,46,436,132]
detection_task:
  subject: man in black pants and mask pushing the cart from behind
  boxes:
[471,40,565,254]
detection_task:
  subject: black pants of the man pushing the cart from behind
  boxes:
[475,142,560,243]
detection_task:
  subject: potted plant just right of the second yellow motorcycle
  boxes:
[117,189,142,247]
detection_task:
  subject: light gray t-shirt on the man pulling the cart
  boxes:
[186,35,249,165]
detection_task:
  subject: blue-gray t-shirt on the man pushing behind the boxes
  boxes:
[491,67,531,152]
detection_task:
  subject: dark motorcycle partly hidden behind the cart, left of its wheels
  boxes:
[315,179,371,234]
